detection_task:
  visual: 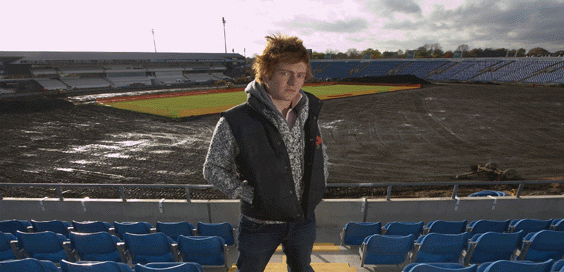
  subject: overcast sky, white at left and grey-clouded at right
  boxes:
[0,0,564,56]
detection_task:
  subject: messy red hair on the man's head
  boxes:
[253,33,312,83]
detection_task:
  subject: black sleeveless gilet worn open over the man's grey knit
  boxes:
[222,93,325,222]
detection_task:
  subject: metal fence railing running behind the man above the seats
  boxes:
[0,180,564,202]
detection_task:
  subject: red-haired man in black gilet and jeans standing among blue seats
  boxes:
[204,34,327,272]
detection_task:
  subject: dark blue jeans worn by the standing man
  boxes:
[237,216,316,272]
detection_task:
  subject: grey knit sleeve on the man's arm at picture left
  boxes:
[204,117,254,203]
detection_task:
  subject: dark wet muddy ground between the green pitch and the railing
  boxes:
[0,84,564,199]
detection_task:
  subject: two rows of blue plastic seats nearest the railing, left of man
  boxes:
[0,220,235,266]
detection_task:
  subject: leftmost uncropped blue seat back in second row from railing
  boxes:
[16,231,71,262]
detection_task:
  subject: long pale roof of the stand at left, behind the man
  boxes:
[0,51,244,64]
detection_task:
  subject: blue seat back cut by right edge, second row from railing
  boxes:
[521,230,564,262]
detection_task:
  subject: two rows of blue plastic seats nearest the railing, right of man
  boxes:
[341,219,564,266]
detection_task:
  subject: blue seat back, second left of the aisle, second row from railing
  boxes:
[123,232,176,264]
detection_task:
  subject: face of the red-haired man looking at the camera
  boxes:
[265,62,307,101]
